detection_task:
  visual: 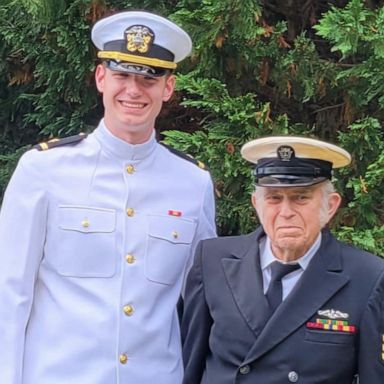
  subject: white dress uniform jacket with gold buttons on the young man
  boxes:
[0,121,215,384]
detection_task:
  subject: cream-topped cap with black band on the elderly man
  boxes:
[241,136,351,187]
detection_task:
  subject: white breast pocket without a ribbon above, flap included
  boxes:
[48,205,116,277]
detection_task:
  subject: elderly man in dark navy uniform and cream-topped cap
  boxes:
[182,137,384,384]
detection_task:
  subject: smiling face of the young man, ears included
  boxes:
[95,64,175,144]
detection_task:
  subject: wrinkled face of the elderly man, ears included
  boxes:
[252,184,341,261]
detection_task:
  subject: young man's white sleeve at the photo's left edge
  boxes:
[0,151,47,384]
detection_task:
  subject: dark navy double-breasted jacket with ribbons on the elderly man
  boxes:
[182,228,384,384]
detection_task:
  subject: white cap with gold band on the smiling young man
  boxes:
[92,11,192,77]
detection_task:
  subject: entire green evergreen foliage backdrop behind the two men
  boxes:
[0,0,384,255]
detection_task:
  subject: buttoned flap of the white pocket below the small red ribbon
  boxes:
[148,215,196,244]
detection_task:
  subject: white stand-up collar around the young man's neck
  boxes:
[94,120,157,160]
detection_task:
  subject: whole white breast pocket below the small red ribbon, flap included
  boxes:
[145,216,196,285]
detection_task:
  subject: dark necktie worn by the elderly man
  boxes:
[266,261,300,313]
